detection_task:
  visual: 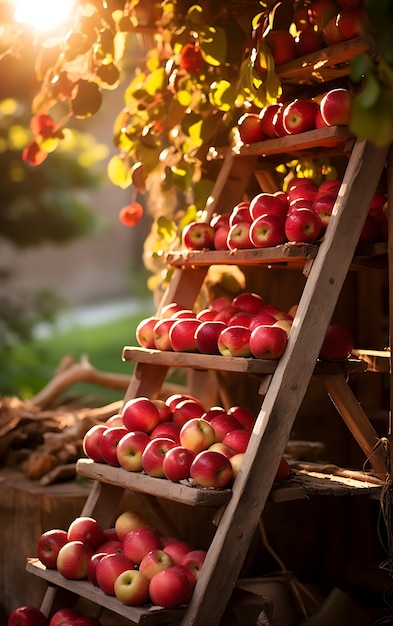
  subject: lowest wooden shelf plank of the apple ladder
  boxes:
[26,559,184,626]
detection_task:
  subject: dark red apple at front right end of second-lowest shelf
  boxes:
[190,450,232,489]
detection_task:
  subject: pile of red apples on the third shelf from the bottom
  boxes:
[136,292,293,360]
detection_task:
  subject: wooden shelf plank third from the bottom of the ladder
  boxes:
[122,346,367,375]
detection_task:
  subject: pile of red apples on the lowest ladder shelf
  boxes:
[33,511,206,608]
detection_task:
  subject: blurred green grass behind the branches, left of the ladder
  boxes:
[4,305,155,405]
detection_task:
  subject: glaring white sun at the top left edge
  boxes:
[13,0,75,32]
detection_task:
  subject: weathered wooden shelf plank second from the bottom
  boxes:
[76,459,232,506]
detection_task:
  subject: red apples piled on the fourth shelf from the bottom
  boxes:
[183,177,388,250]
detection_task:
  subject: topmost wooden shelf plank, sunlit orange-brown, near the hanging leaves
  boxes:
[277,37,369,86]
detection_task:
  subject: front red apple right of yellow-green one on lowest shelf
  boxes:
[149,565,192,609]
